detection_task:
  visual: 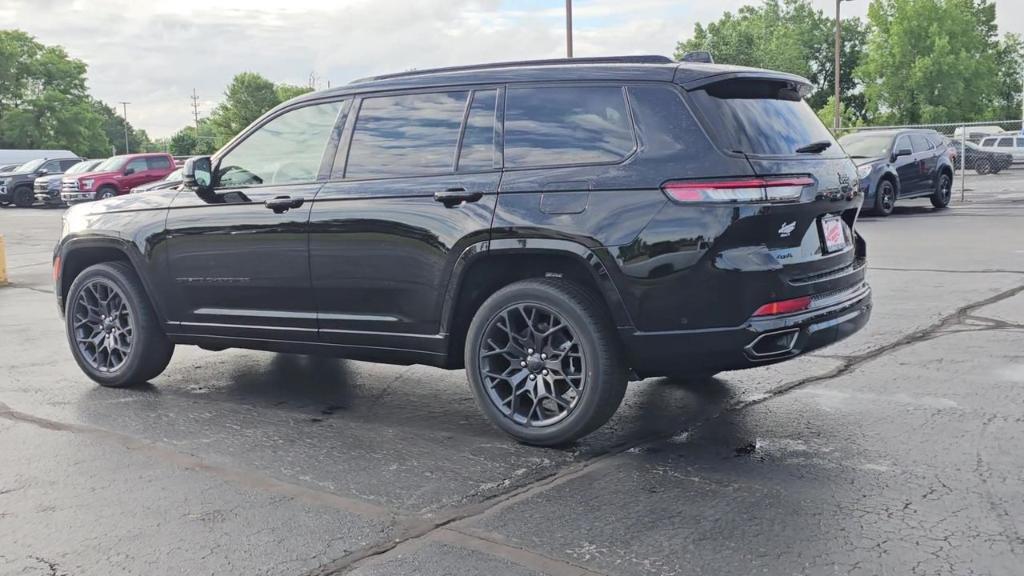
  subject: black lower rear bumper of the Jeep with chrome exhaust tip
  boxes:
[620,283,871,377]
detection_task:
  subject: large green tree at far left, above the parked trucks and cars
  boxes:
[0,30,110,156]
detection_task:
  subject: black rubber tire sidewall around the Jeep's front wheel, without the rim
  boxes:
[65,264,153,386]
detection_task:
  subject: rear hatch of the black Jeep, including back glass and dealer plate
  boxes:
[667,73,864,322]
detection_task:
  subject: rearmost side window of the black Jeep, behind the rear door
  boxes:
[505,86,636,168]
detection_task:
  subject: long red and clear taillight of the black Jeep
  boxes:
[662,176,814,203]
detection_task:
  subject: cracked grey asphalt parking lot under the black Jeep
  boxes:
[0,170,1024,576]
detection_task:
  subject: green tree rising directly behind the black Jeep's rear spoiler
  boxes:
[676,0,867,117]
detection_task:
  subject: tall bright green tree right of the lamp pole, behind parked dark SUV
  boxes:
[856,0,999,124]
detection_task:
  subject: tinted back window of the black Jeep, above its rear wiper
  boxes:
[690,79,842,156]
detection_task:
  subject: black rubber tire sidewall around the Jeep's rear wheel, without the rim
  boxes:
[465,283,626,446]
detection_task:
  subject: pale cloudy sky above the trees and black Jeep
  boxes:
[0,0,1024,137]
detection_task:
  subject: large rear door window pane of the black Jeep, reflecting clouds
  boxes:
[345,91,468,178]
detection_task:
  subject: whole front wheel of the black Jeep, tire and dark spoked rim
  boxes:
[65,262,174,387]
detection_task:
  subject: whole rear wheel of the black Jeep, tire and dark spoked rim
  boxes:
[465,279,627,446]
